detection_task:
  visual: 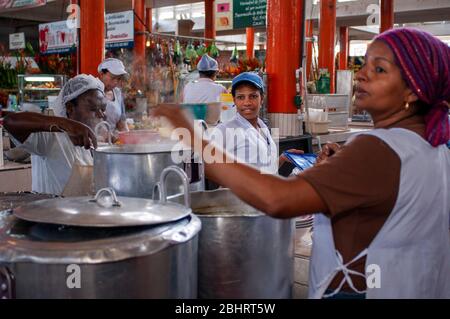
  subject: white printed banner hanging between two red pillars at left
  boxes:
[105,10,134,49]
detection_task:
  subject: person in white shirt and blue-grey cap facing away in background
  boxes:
[183,54,227,124]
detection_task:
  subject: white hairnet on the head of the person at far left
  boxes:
[53,74,105,117]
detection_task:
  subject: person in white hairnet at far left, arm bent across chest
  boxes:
[3,74,106,195]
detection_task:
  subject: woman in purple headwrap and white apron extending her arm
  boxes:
[155,28,450,298]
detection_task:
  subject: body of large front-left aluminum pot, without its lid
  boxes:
[0,168,201,299]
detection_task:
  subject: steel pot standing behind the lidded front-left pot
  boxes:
[94,122,205,198]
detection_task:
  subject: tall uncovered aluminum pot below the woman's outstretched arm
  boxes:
[170,189,295,299]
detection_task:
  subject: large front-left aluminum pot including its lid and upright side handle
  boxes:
[0,167,201,298]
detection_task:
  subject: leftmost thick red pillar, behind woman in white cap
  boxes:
[79,0,105,75]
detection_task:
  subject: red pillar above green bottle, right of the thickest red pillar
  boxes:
[319,0,336,93]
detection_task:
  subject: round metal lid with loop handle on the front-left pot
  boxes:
[13,188,191,227]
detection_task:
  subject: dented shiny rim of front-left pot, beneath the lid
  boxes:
[0,211,201,264]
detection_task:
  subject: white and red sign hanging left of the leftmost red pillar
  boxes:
[39,21,78,54]
